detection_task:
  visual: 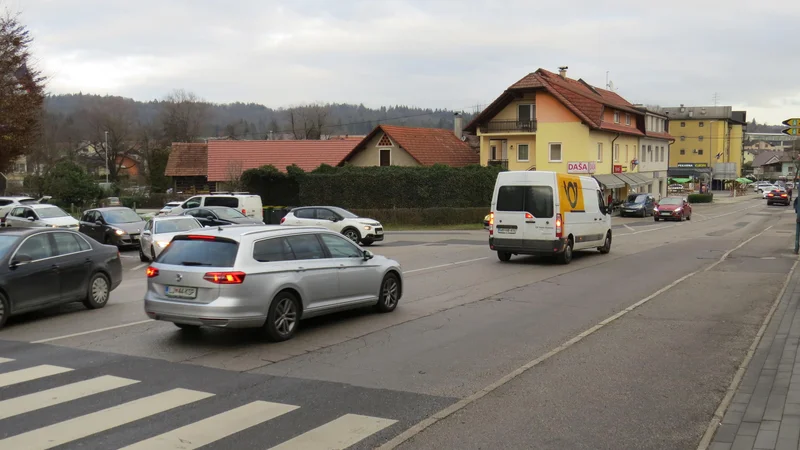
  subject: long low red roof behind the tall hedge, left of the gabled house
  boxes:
[208,139,361,181]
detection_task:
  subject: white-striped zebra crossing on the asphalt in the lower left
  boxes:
[0,357,398,450]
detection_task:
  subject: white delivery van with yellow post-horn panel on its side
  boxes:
[489,171,611,264]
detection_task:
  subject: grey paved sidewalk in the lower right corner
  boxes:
[709,258,800,450]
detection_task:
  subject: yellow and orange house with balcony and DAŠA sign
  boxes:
[464,67,653,198]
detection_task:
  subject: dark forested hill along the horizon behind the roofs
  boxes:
[45,94,472,139]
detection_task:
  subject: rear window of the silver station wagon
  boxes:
[156,239,239,267]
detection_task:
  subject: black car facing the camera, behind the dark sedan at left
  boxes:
[79,207,145,247]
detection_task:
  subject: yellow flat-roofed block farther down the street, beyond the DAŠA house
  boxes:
[662,105,747,189]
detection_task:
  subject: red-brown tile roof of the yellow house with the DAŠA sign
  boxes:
[464,69,643,136]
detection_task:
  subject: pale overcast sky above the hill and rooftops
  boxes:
[12,0,800,124]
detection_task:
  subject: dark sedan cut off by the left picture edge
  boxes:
[0,228,122,328]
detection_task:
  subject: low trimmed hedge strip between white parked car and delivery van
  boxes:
[350,205,489,225]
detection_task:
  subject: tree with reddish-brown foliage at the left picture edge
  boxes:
[0,12,45,170]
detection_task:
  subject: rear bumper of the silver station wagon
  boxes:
[144,292,267,328]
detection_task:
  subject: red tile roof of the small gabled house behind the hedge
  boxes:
[348,125,480,167]
